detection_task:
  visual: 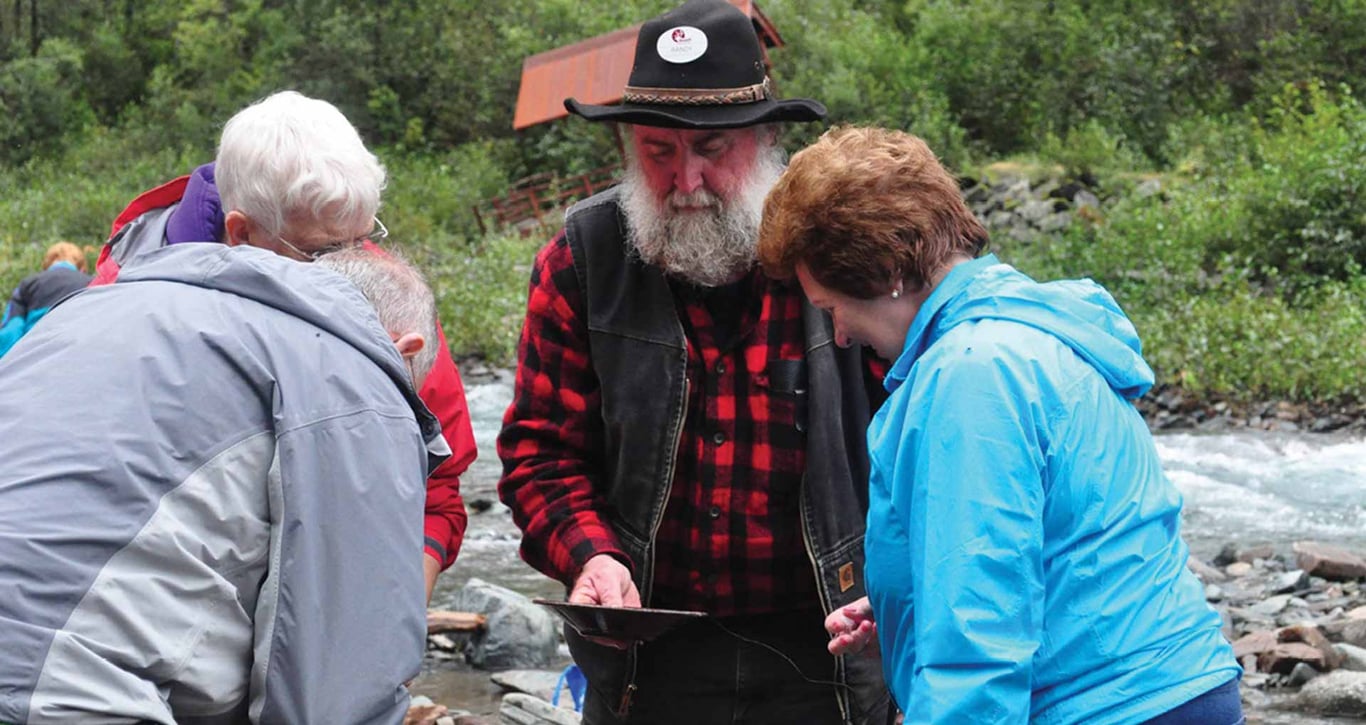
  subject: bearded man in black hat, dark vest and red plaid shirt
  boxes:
[499,0,888,725]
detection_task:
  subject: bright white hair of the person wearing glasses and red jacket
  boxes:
[214,90,384,235]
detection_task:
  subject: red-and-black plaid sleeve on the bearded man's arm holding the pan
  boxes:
[499,233,627,584]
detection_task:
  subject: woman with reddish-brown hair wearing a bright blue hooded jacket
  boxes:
[759,128,1243,725]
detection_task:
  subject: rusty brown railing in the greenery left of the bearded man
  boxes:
[474,165,622,236]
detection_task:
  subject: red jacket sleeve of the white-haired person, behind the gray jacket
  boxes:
[418,320,478,569]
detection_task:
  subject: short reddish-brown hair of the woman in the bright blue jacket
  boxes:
[758,127,988,299]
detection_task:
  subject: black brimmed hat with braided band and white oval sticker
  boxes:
[564,0,825,128]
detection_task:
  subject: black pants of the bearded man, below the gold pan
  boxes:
[566,609,844,725]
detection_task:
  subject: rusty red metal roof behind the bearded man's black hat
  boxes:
[512,0,783,131]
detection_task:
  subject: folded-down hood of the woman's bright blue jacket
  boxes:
[888,254,1154,399]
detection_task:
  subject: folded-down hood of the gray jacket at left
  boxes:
[115,243,451,458]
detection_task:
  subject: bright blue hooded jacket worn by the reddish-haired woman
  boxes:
[866,255,1242,724]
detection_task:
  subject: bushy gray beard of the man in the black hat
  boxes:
[620,145,784,287]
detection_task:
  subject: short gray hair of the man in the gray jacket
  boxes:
[314,248,441,385]
